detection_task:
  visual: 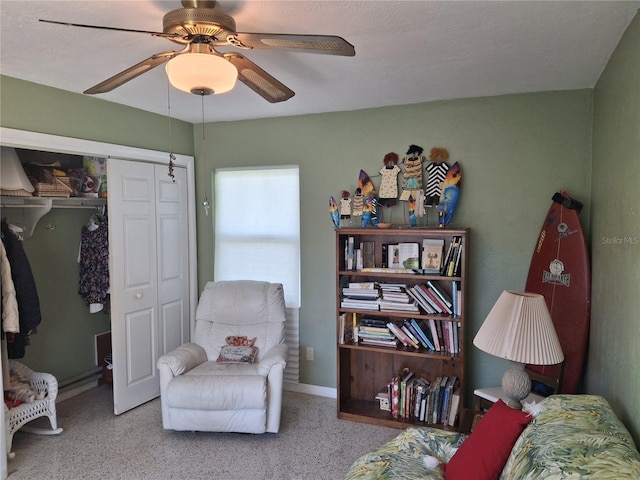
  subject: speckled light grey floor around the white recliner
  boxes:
[7,386,399,480]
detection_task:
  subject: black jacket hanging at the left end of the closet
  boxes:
[1,220,42,358]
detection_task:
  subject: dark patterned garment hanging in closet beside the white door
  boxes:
[78,217,109,313]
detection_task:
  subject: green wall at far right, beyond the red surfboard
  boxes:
[587,11,640,445]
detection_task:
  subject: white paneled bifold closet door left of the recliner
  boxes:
[107,159,189,414]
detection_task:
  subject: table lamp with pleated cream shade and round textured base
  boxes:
[473,290,564,410]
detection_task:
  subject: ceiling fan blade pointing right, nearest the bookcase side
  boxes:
[229,33,356,57]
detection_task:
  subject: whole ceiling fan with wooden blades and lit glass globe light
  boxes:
[40,0,355,103]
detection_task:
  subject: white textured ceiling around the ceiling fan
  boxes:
[0,0,640,123]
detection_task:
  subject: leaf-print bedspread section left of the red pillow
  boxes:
[345,427,467,480]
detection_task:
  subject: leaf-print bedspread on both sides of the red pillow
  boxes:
[345,395,640,480]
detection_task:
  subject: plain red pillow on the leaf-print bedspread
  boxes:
[443,399,531,480]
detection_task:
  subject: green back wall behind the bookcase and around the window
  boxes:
[194,90,592,398]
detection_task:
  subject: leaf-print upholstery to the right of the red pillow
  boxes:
[500,395,640,480]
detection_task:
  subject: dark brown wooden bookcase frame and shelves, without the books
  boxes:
[335,227,469,430]
